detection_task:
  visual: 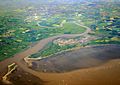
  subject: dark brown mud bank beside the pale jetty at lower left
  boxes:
[0,67,45,85]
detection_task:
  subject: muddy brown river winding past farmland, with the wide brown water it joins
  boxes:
[0,23,120,85]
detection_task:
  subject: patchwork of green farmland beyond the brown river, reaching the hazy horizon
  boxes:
[0,0,120,61]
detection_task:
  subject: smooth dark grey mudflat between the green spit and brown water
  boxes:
[32,45,120,73]
